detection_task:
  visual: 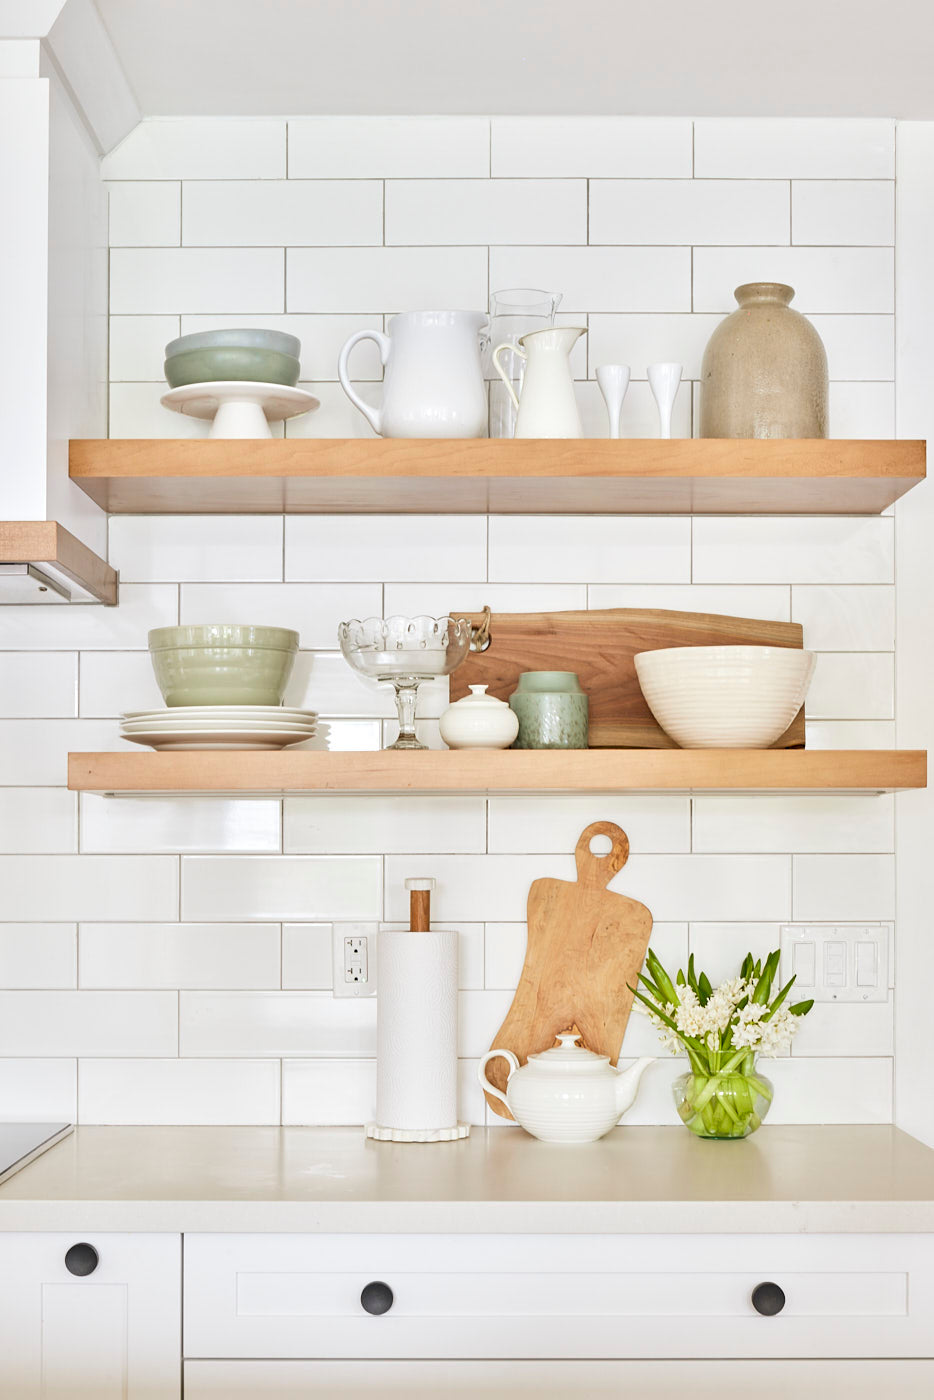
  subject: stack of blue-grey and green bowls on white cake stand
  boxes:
[164,329,301,389]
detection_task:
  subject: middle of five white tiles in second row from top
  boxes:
[380,179,585,246]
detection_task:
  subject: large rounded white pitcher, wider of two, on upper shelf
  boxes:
[337,311,487,437]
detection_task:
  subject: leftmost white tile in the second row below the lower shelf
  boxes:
[0,845,178,924]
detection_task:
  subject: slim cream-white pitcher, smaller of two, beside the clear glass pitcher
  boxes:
[493,326,587,437]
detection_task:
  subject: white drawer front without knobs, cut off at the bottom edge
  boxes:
[185,1361,934,1400]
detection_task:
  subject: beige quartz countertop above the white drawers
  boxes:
[0,1126,934,1233]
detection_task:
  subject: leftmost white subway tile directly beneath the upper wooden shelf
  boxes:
[108,515,283,584]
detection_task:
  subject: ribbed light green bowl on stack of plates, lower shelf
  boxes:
[148,623,298,706]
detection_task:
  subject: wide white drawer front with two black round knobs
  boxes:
[185,1235,934,1358]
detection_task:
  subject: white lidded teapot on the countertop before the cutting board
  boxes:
[478,1030,655,1142]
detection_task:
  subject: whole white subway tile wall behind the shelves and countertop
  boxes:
[0,119,895,1123]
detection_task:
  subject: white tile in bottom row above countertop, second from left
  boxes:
[78,1060,279,1126]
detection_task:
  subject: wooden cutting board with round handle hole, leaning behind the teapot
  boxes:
[486,822,653,1119]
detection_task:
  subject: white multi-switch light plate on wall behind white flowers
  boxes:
[780,924,892,1002]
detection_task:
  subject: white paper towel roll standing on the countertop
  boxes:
[377,928,458,1130]
